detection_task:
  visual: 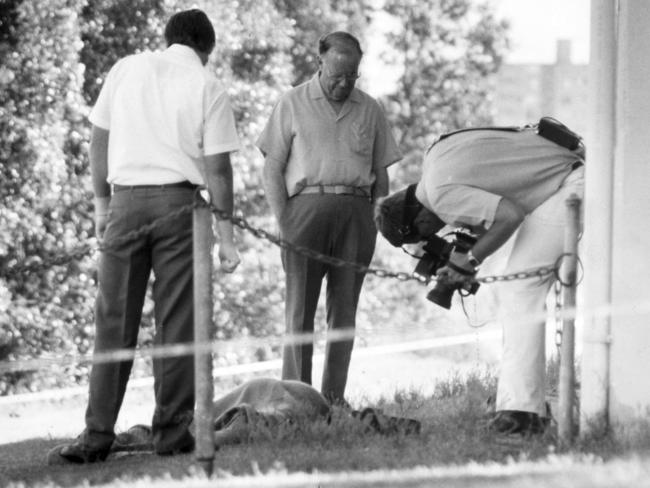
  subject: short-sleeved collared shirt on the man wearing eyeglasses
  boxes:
[256,75,402,197]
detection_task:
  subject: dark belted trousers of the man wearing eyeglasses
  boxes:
[280,194,377,401]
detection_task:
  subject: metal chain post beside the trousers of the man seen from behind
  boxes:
[193,194,215,477]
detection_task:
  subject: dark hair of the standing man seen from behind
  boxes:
[165,8,216,54]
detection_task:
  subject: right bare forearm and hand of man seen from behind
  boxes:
[204,152,239,273]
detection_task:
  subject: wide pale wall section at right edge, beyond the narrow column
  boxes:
[604,0,650,424]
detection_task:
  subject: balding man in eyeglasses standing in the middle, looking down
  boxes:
[257,31,401,403]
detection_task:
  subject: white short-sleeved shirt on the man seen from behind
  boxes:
[89,44,240,185]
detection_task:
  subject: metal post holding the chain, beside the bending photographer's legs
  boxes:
[558,194,581,445]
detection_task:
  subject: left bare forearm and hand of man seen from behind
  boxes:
[89,125,111,239]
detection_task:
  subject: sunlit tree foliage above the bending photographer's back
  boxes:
[385,0,508,186]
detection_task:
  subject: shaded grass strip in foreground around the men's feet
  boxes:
[0,373,650,487]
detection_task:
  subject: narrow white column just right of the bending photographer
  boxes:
[580,0,617,434]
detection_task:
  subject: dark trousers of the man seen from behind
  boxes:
[85,188,194,452]
